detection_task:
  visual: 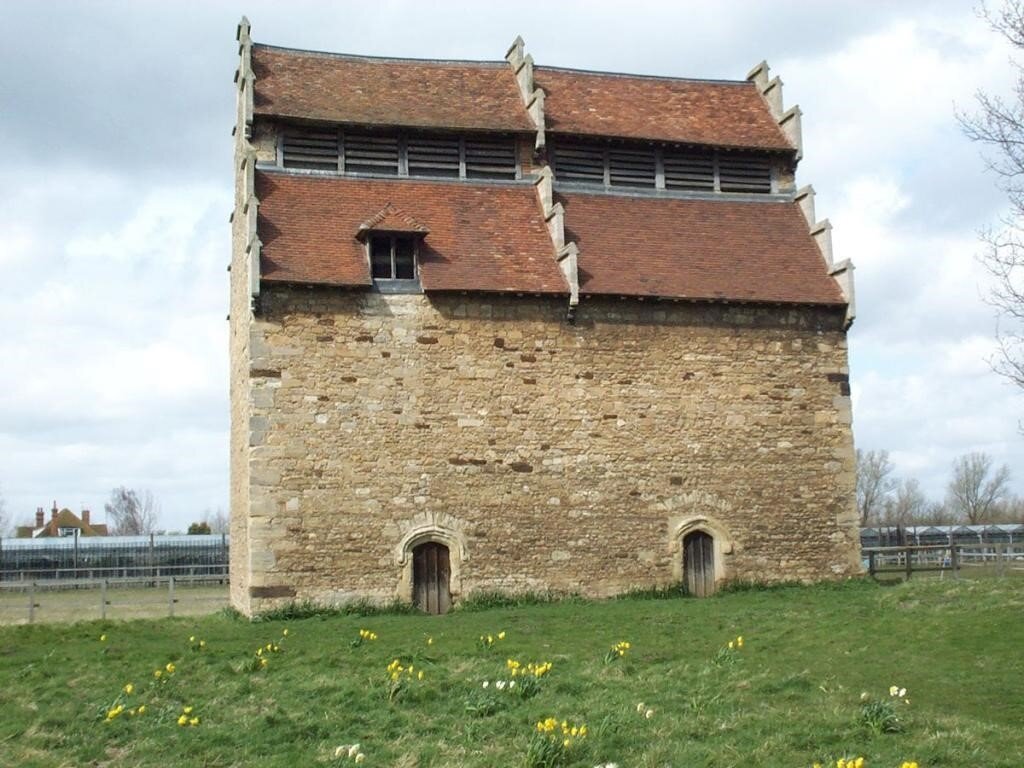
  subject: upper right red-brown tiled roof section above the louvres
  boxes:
[534,67,794,152]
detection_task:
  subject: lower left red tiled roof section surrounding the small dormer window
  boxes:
[256,171,568,294]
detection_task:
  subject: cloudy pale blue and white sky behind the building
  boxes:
[0,0,1024,529]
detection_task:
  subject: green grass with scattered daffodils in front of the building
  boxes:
[0,580,1024,768]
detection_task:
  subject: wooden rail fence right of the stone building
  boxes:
[861,543,1024,579]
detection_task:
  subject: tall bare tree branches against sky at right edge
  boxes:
[957,0,1024,388]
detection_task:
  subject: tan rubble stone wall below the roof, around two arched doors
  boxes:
[232,284,859,612]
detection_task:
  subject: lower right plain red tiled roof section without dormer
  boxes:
[558,193,846,305]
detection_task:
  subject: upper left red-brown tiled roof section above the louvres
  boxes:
[252,45,536,132]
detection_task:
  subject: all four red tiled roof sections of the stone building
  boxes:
[241,36,846,313]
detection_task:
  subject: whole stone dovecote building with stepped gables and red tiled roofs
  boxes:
[230,19,859,613]
